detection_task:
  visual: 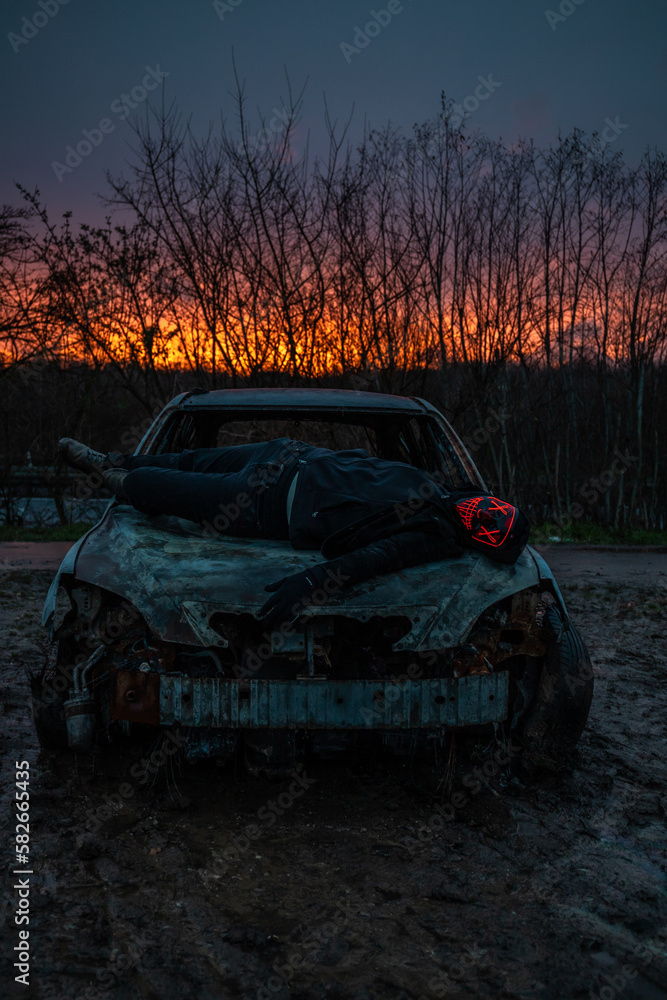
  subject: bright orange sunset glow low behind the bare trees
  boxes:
[0,292,656,377]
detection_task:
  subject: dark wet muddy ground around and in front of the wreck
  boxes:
[0,552,667,1000]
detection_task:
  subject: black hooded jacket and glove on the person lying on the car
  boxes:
[260,451,530,628]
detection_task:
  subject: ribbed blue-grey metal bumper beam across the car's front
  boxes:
[159,672,509,729]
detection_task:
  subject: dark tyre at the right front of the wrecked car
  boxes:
[521,604,593,773]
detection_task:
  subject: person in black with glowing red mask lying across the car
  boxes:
[59,437,530,628]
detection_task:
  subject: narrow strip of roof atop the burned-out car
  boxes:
[180,388,431,413]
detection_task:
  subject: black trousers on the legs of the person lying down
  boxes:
[120,438,310,539]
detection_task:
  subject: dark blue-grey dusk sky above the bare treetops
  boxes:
[0,0,667,222]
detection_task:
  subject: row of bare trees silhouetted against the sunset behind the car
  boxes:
[0,89,667,528]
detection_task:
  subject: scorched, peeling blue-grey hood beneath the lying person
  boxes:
[43,505,548,651]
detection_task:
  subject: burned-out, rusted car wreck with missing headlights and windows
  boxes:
[35,389,592,772]
